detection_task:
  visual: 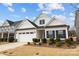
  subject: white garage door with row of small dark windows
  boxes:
[16,31,36,42]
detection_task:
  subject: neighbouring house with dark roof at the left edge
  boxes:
[0,20,22,38]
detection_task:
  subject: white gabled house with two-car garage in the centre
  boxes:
[15,14,69,42]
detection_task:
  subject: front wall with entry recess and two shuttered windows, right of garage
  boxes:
[37,28,68,40]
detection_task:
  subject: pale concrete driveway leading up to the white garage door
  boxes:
[0,43,27,56]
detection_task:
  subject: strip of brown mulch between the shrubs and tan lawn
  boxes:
[24,43,76,49]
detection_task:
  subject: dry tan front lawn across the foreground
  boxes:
[1,45,79,56]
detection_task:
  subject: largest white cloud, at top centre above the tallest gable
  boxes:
[37,3,65,14]
